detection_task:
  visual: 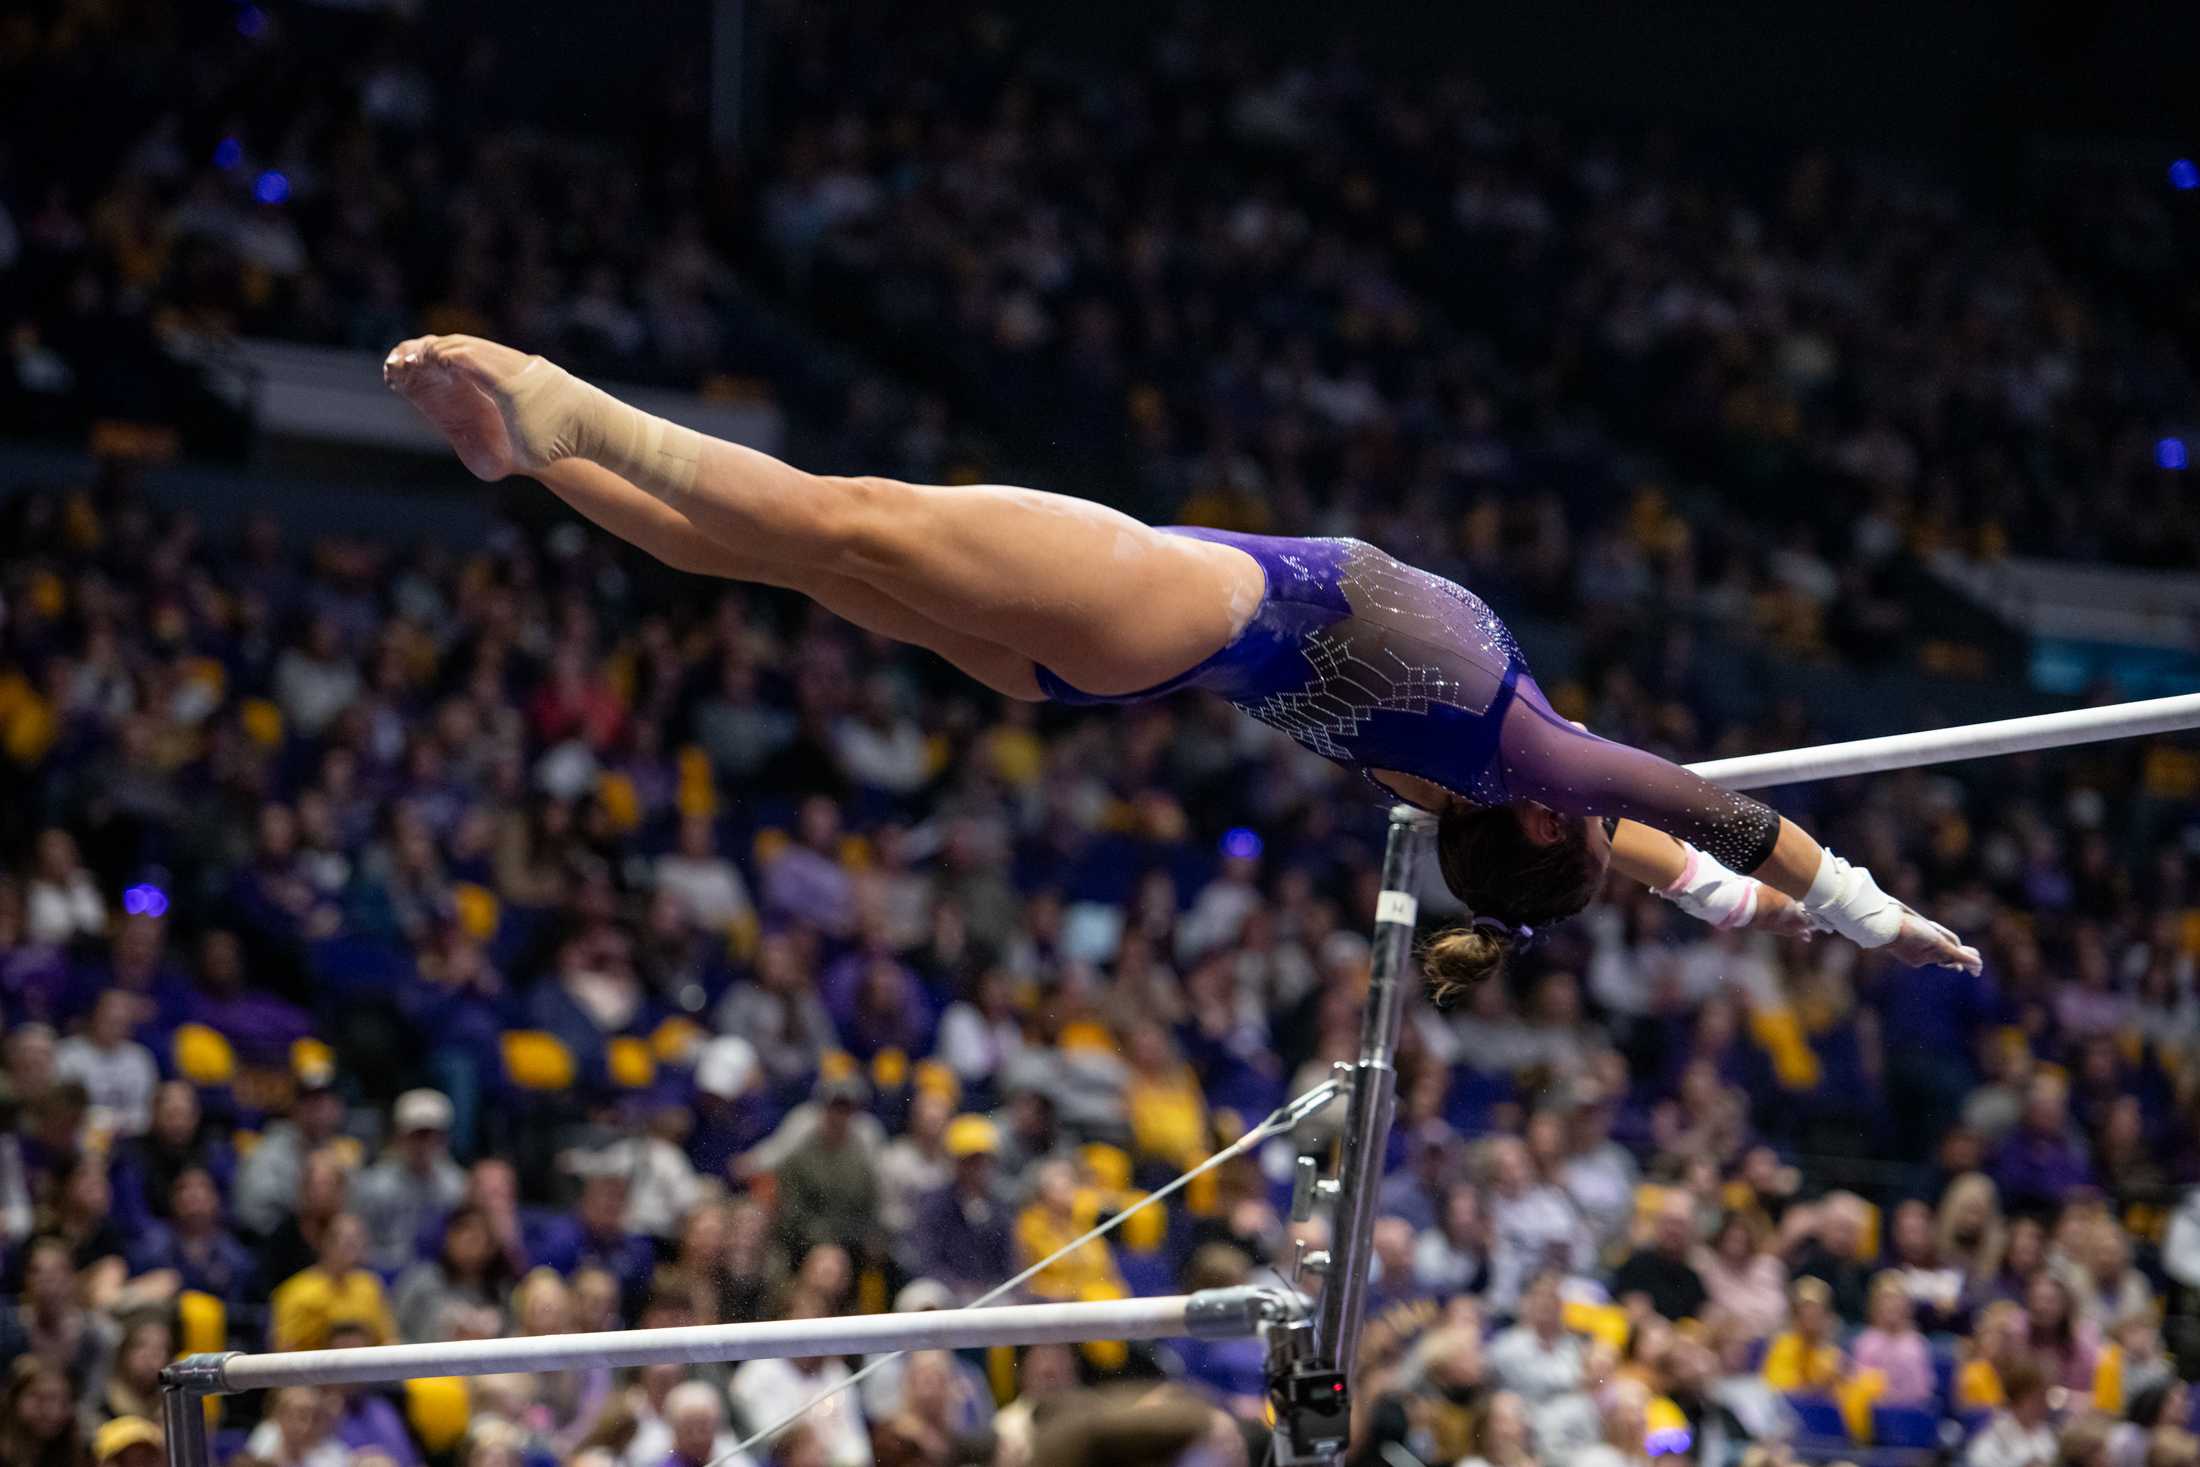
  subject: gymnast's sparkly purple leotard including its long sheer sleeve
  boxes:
[1036,526,1780,871]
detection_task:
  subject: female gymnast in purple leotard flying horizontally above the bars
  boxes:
[383,337,1980,996]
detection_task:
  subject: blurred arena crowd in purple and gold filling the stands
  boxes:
[0,4,2200,1467]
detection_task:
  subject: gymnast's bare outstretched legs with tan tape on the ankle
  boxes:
[387,337,1261,693]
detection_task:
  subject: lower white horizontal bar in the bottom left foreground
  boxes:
[161,1287,1300,1397]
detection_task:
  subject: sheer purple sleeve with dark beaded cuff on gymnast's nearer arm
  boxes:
[1498,677,1780,873]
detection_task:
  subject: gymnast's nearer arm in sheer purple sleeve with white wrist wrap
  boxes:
[1498,695,1980,972]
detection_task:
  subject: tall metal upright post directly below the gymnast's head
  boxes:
[1313,805,1434,1379]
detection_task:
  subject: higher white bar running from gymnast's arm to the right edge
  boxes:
[1687,693,2200,790]
